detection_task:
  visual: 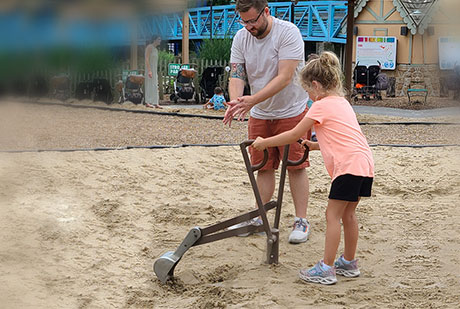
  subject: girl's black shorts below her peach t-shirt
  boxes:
[329,174,374,202]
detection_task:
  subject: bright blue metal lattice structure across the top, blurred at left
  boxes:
[0,1,347,52]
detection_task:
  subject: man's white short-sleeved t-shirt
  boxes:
[230,17,308,119]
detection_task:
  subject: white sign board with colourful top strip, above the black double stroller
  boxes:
[356,36,397,70]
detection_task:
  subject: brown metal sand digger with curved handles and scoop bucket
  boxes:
[153,140,309,283]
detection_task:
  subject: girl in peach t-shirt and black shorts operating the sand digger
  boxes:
[252,52,374,284]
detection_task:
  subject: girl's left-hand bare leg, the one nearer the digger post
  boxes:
[324,199,349,266]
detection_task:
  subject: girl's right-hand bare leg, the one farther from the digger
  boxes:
[342,201,359,261]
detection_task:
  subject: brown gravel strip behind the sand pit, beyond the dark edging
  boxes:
[0,103,460,150]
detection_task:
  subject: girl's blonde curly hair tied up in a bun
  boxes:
[299,51,345,96]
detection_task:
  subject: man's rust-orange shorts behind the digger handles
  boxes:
[248,109,311,170]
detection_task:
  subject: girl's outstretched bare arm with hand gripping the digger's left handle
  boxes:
[252,117,315,150]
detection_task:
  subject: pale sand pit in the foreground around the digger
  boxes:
[0,147,460,308]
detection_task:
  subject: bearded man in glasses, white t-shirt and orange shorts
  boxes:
[223,0,310,243]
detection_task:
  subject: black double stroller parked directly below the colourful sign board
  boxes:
[352,62,388,102]
